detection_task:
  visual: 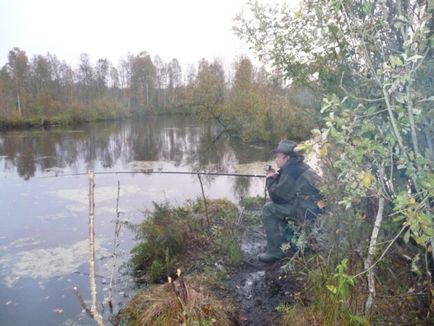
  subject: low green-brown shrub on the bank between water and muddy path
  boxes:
[131,200,242,282]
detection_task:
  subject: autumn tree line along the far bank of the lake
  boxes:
[0,48,315,141]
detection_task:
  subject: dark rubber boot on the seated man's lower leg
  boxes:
[258,215,286,263]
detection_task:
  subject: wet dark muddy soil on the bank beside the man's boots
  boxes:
[225,220,299,326]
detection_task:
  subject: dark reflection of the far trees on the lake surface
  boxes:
[0,116,268,196]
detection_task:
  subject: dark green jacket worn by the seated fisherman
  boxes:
[266,156,321,207]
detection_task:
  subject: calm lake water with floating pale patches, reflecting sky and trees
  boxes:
[0,116,270,326]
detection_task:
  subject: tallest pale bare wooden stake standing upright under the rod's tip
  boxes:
[88,171,104,326]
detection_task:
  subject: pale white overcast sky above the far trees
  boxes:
[0,0,298,67]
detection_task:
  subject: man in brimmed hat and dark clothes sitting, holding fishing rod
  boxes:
[258,139,323,263]
